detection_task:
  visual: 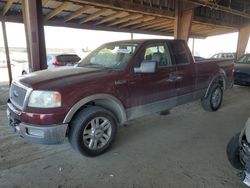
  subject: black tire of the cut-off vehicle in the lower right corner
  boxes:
[227,133,244,170]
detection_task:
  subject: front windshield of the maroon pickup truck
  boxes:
[78,43,138,69]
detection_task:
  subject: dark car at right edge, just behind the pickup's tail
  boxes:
[234,54,250,86]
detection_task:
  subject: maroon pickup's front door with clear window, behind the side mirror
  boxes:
[129,43,176,107]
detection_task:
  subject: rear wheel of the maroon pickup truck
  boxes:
[201,83,223,112]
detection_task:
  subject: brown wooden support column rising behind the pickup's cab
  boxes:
[174,0,195,42]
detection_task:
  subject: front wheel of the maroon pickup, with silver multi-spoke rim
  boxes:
[68,106,117,157]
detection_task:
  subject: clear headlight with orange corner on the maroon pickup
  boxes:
[28,90,61,108]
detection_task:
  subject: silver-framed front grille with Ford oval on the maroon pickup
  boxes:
[10,83,27,109]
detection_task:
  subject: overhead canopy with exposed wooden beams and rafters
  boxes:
[0,0,250,37]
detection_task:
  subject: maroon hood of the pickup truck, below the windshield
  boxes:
[17,67,111,90]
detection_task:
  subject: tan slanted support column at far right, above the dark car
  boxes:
[236,25,250,59]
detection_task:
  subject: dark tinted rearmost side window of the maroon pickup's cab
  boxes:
[169,41,190,65]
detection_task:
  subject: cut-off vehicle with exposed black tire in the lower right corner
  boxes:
[227,118,250,187]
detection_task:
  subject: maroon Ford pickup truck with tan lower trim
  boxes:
[7,40,233,156]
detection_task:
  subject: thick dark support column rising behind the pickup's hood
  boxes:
[22,0,47,72]
